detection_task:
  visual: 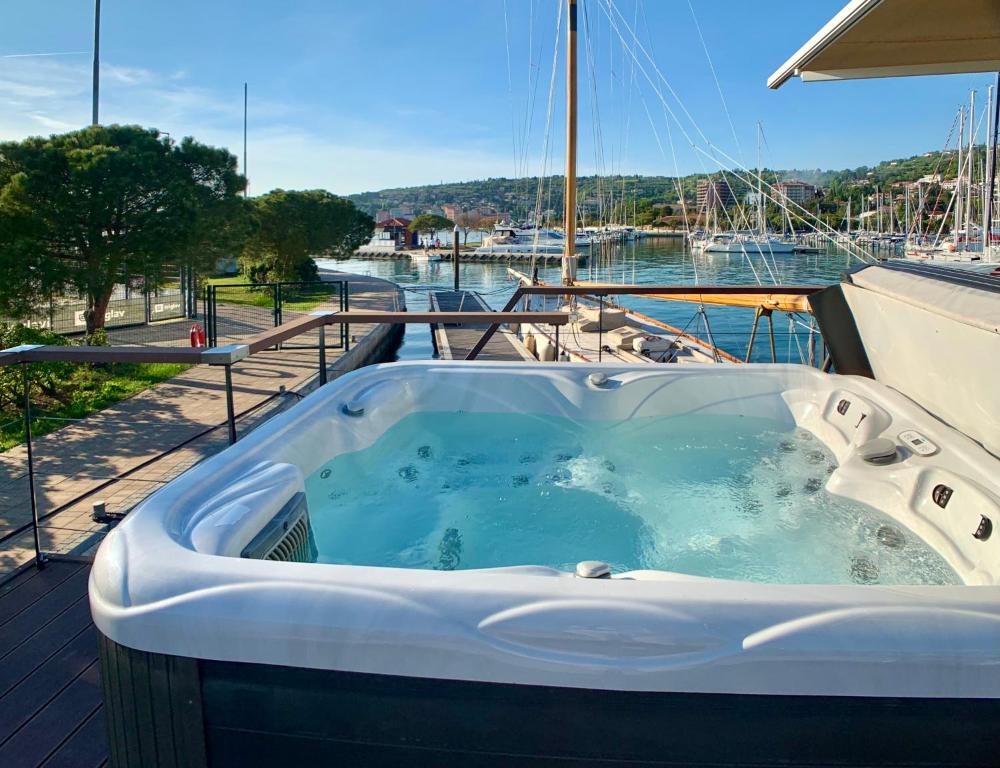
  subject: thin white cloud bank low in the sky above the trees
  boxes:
[0,59,510,194]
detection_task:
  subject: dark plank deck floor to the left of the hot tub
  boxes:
[0,560,108,768]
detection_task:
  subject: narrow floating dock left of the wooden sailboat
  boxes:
[429,291,535,362]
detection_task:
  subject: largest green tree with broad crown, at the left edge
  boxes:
[0,125,244,334]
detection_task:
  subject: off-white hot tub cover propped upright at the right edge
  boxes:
[843,261,1000,456]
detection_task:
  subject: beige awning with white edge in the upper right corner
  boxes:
[767,0,1000,88]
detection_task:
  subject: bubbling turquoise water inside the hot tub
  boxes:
[306,412,961,584]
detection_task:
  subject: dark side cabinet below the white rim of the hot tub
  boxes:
[95,637,1000,768]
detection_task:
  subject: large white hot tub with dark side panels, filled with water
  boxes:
[90,362,1000,765]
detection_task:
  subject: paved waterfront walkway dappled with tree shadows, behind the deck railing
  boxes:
[0,273,405,578]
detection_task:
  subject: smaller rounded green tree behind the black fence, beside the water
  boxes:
[241,189,375,282]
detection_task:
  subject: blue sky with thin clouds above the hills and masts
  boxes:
[0,0,992,193]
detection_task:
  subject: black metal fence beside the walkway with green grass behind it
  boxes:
[202,280,349,348]
